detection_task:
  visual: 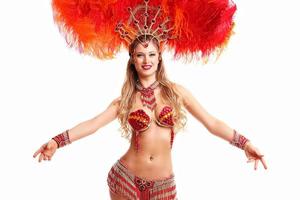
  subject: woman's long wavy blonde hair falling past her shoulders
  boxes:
[118,35,186,139]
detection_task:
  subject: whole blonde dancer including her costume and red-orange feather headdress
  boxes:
[33,0,267,200]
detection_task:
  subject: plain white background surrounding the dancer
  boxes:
[0,0,300,200]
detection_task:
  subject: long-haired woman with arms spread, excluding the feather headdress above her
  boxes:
[34,1,267,200]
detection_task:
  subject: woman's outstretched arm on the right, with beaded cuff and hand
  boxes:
[176,84,267,170]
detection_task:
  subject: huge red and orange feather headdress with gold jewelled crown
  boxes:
[52,0,236,59]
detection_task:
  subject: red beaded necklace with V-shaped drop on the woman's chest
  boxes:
[136,81,159,111]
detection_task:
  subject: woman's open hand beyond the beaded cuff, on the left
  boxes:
[33,140,57,162]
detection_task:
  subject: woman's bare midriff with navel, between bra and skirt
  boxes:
[120,121,173,180]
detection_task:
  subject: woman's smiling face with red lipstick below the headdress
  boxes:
[133,42,159,78]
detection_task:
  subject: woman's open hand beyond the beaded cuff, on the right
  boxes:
[244,142,267,170]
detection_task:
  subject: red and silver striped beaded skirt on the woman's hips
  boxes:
[107,160,177,200]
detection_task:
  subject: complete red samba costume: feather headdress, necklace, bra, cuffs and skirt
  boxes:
[52,0,247,200]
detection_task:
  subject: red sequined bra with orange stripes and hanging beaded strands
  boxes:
[128,106,174,151]
